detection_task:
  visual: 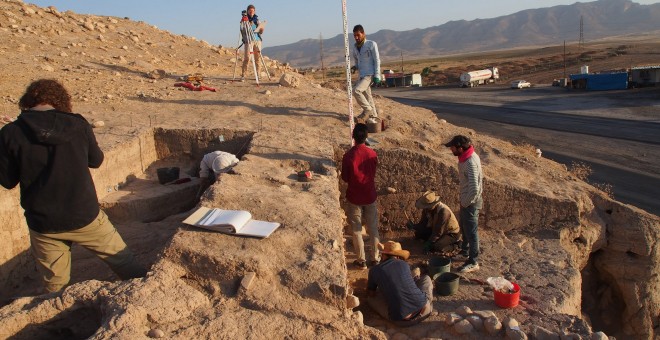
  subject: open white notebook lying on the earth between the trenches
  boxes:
[183,207,280,238]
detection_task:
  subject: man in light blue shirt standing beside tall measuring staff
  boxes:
[351,25,380,119]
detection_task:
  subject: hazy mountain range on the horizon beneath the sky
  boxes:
[264,0,660,68]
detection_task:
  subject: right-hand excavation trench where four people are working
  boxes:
[335,146,625,334]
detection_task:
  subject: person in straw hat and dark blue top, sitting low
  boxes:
[367,241,433,327]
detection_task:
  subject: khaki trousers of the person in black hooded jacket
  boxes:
[30,210,146,292]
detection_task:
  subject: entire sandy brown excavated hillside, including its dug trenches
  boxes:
[0,1,660,339]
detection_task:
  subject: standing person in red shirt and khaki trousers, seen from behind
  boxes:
[341,123,380,269]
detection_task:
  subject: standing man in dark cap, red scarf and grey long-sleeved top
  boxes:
[445,135,484,273]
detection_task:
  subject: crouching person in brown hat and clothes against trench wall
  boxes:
[408,191,461,255]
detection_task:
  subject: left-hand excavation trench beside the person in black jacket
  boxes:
[2,128,254,305]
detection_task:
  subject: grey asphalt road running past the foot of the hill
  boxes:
[376,86,660,215]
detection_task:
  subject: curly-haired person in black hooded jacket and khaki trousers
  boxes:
[0,79,146,292]
